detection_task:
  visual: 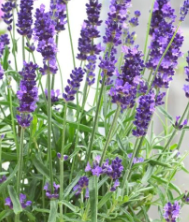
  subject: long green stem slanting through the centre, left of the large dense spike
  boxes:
[86,75,106,163]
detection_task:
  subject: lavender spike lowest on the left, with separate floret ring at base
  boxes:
[17,62,38,127]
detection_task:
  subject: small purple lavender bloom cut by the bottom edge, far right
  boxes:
[163,201,180,222]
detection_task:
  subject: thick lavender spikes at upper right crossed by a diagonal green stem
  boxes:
[146,0,184,88]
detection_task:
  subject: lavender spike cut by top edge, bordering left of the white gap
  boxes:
[50,0,67,32]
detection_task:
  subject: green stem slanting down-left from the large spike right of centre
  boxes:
[100,106,121,165]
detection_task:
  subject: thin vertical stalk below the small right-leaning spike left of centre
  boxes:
[59,102,68,221]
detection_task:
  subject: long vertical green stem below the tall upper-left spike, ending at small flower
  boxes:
[47,71,53,191]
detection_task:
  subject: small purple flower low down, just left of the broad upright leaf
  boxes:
[73,176,89,198]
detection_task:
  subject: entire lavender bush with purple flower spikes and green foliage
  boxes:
[0,0,189,222]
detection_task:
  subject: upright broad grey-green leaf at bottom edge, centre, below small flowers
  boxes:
[89,176,98,222]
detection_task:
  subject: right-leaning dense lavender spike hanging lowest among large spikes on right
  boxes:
[133,92,155,137]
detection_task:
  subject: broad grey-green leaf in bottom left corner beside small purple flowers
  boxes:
[8,185,23,214]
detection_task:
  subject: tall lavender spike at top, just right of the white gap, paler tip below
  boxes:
[77,0,102,85]
